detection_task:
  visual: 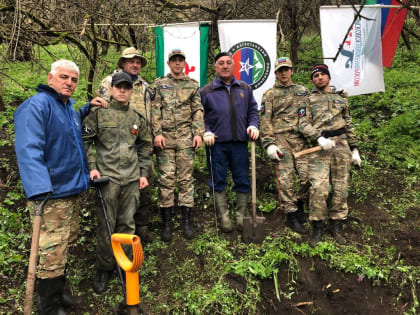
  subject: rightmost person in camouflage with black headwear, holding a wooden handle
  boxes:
[299,64,361,246]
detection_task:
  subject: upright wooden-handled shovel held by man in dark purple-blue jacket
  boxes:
[243,141,265,243]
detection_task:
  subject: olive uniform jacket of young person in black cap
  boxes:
[83,100,152,185]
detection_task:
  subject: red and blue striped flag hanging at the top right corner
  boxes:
[366,0,407,67]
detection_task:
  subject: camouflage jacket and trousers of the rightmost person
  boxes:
[299,88,357,221]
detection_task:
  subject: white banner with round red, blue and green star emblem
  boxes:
[218,20,277,106]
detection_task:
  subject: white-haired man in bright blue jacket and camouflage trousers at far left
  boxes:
[14,60,100,315]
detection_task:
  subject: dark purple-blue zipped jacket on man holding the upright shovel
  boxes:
[201,77,259,142]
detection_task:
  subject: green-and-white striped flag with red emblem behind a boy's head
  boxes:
[154,22,209,86]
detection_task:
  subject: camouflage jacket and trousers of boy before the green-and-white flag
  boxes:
[152,73,204,208]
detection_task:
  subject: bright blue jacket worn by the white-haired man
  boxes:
[14,84,89,199]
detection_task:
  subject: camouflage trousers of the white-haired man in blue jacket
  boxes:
[27,195,80,279]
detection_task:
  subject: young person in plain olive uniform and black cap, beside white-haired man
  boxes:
[83,72,152,293]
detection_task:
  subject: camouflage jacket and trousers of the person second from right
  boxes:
[260,81,309,213]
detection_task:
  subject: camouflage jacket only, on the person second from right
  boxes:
[260,81,309,150]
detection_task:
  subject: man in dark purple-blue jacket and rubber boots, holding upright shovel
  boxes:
[201,52,259,233]
